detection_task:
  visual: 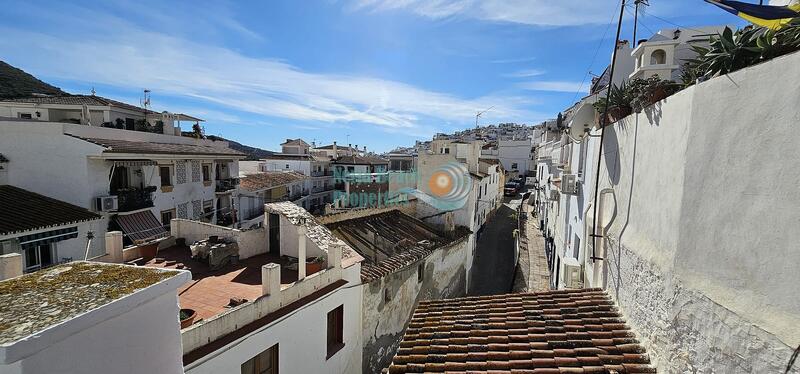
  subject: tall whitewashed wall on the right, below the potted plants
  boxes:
[588,53,800,373]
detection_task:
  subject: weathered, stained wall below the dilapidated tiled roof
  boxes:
[361,237,469,374]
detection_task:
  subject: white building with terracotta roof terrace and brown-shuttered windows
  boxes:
[145,202,363,374]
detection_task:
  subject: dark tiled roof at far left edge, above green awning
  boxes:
[0,185,100,234]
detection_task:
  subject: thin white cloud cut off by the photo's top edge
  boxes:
[350,0,618,26]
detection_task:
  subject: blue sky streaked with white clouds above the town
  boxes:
[0,0,752,151]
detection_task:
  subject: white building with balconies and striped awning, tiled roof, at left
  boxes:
[0,120,244,255]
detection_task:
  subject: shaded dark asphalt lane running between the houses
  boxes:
[469,196,521,296]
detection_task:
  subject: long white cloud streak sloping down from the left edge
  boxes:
[0,7,543,133]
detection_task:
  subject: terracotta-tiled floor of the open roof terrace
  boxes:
[142,246,297,319]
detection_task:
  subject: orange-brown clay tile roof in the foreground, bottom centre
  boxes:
[389,289,656,374]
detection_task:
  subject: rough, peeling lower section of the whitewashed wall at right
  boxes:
[608,238,800,373]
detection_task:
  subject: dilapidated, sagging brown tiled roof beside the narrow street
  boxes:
[327,210,467,282]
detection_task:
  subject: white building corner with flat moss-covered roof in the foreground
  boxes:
[0,262,190,374]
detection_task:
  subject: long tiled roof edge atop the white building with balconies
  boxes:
[76,136,245,157]
